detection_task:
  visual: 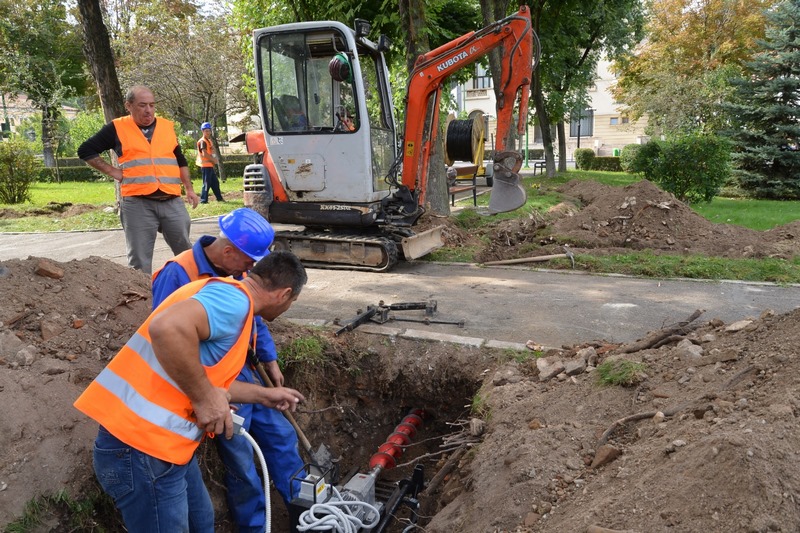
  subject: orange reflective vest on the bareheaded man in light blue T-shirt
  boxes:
[74,278,253,464]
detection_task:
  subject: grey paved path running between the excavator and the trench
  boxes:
[0,218,800,346]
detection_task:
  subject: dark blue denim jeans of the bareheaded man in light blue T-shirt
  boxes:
[94,426,214,533]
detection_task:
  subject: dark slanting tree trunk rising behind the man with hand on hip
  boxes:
[78,0,126,122]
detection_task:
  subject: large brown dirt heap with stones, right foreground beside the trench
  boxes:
[426,310,800,533]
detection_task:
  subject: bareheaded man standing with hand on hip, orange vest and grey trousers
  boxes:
[78,85,199,274]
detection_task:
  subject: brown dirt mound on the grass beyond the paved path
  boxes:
[476,180,800,262]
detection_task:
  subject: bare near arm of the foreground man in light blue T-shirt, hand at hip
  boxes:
[149,298,233,438]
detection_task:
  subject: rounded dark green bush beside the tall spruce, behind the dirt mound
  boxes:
[632,134,730,203]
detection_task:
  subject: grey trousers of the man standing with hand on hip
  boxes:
[119,196,192,274]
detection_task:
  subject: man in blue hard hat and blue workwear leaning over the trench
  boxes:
[153,208,303,532]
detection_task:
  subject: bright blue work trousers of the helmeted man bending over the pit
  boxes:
[214,367,303,533]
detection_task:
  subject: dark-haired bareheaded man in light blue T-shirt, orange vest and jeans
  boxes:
[75,252,307,533]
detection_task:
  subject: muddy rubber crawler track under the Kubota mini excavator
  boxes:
[273,231,398,272]
